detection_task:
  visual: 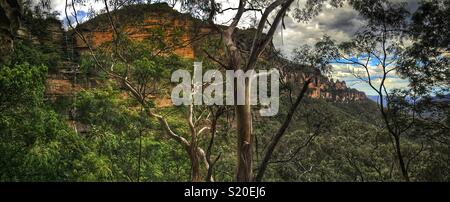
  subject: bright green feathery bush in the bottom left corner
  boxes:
[0,108,85,181]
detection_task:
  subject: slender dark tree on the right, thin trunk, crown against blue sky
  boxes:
[330,1,414,181]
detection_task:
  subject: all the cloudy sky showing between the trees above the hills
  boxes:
[44,0,418,95]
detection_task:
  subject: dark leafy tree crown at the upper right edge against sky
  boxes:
[398,0,450,95]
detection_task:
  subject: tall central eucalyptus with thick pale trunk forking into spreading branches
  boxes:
[200,0,341,181]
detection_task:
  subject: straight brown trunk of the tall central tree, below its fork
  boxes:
[235,79,253,182]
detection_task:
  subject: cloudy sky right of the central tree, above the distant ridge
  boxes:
[273,0,418,95]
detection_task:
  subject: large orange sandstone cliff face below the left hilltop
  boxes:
[72,3,212,59]
